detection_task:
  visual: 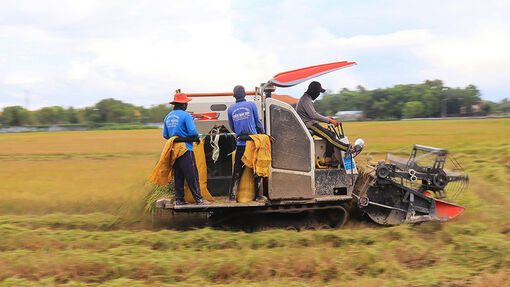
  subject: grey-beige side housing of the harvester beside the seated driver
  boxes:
[265,94,358,202]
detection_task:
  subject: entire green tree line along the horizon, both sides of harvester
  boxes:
[0,80,510,126]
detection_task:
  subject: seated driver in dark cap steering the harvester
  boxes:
[296,81,352,165]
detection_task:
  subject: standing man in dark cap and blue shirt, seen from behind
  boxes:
[226,85,265,203]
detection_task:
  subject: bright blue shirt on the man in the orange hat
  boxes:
[163,110,198,151]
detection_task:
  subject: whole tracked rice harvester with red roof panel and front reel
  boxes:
[156,61,468,231]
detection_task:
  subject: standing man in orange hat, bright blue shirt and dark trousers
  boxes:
[163,93,210,205]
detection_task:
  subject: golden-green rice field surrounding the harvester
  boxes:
[0,119,510,286]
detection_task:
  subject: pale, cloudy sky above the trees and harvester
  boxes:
[0,0,510,110]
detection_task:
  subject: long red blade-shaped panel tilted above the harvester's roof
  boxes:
[269,61,356,87]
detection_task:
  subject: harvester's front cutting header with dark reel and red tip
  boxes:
[353,145,468,225]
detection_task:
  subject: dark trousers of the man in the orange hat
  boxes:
[173,151,202,202]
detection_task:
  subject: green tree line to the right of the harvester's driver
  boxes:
[315,80,510,120]
